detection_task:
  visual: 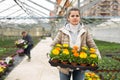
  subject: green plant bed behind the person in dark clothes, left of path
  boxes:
[0,36,40,58]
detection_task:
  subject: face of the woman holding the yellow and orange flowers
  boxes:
[68,11,80,25]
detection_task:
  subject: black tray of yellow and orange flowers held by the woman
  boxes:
[49,44,98,70]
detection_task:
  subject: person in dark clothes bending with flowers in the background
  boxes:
[22,31,33,61]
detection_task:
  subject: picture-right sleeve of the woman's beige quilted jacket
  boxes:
[86,31,101,59]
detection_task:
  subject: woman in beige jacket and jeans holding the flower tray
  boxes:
[52,8,101,80]
